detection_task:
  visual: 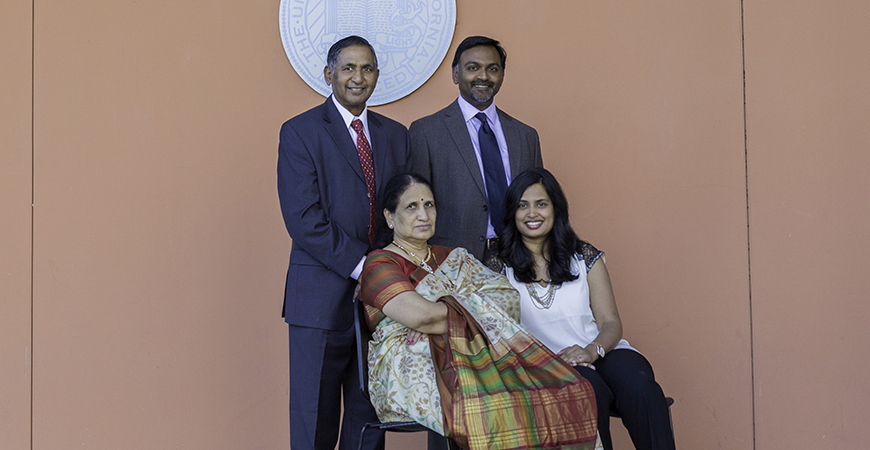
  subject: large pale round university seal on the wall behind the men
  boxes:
[278,0,456,106]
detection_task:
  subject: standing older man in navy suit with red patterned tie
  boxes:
[278,36,409,450]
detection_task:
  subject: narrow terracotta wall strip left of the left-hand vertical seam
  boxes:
[0,1,33,449]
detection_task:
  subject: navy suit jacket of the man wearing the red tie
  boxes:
[278,98,410,330]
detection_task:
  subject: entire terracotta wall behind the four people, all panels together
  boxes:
[0,0,870,450]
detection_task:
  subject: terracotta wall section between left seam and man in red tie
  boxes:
[33,1,292,449]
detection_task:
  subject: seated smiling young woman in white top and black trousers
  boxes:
[499,169,674,450]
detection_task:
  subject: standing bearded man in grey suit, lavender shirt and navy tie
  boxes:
[410,36,543,268]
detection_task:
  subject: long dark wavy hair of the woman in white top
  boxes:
[499,168,581,284]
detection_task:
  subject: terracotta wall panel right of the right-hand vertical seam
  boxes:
[745,1,870,449]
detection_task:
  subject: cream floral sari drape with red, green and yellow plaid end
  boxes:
[369,249,597,450]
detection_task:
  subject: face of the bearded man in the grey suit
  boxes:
[453,45,504,111]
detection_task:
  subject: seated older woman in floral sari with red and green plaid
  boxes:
[360,174,598,450]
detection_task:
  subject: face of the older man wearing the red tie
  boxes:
[323,45,378,116]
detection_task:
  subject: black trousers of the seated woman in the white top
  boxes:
[574,349,674,450]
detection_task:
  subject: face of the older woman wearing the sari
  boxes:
[384,183,436,247]
